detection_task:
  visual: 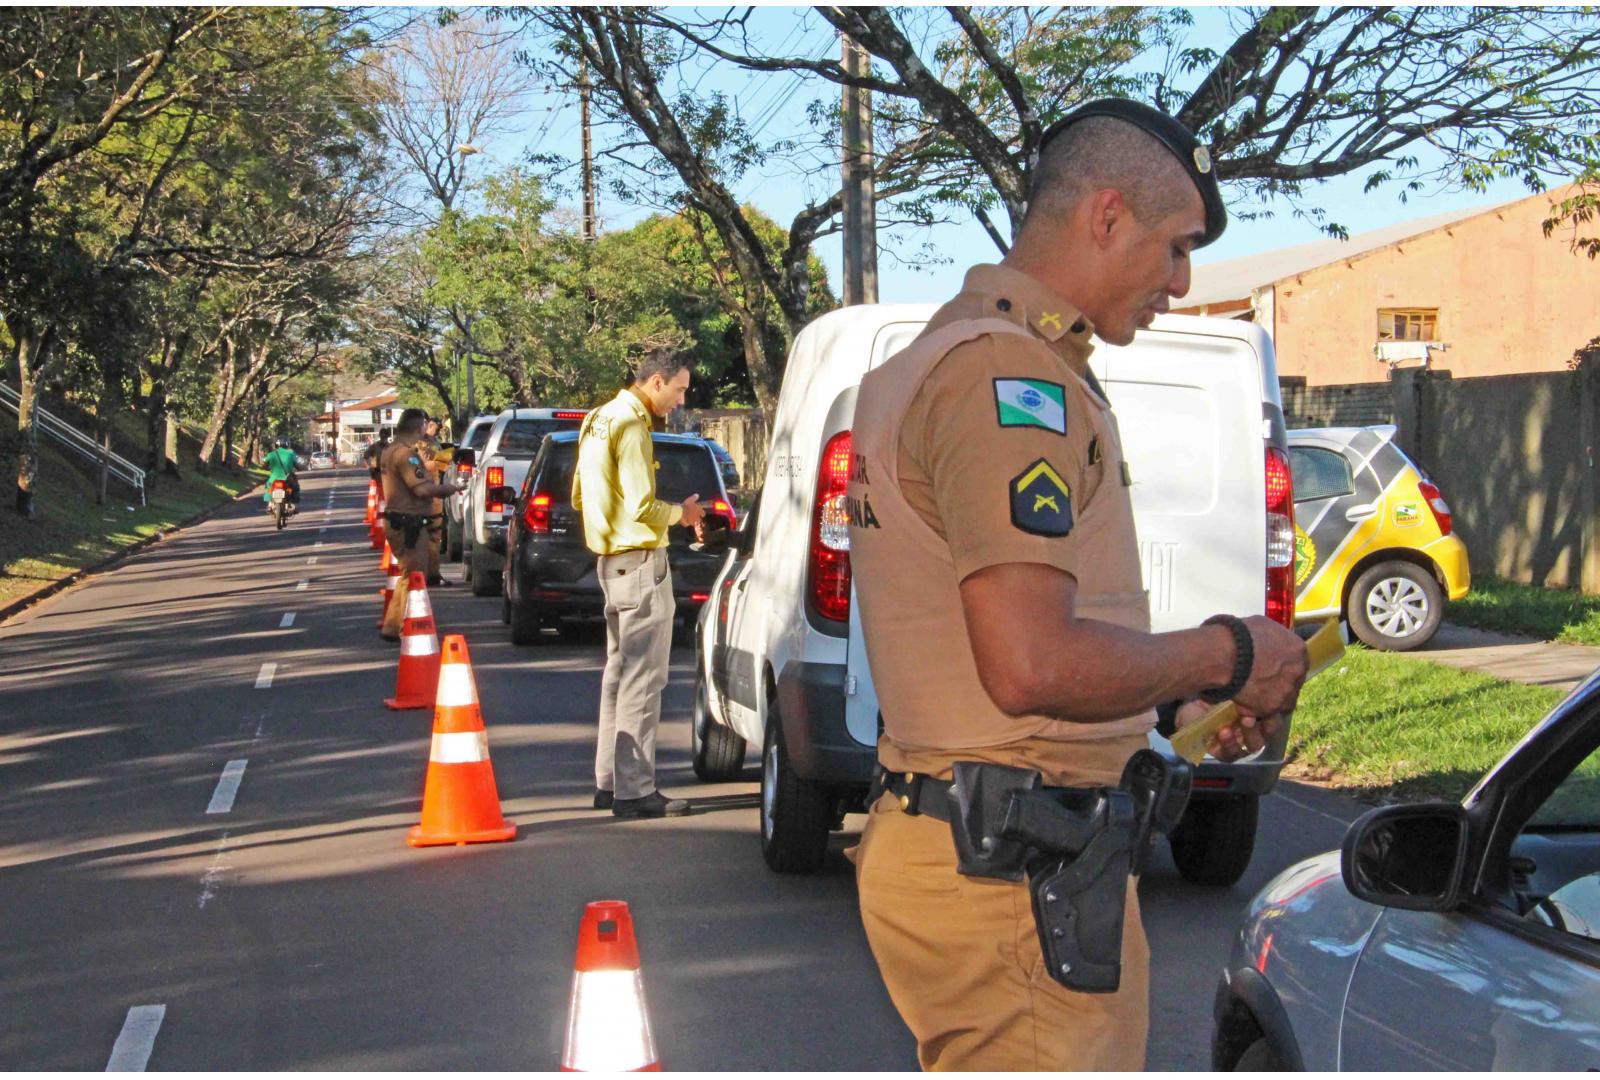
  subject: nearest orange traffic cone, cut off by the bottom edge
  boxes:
[562,901,661,1072]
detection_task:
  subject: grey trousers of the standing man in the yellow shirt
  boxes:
[595,547,677,798]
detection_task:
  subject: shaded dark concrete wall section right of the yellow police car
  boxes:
[1392,365,1600,592]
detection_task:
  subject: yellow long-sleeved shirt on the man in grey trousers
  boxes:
[573,389,683,555]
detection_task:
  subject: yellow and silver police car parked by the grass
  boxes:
[1290,424,1472,651]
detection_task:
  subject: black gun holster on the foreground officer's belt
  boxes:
[946,750,1194,994]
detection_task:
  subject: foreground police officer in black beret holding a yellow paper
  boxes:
[848,99,1306,1070]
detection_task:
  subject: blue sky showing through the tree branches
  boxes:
[478,6,1548,302]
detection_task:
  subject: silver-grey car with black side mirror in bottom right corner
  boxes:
[1211,674,1600,1074]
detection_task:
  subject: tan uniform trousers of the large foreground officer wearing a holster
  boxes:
[856,739,1150,1072]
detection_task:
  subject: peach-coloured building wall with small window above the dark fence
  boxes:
[1262,194,1600,386]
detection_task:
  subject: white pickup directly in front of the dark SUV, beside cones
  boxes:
[461,408,587,597]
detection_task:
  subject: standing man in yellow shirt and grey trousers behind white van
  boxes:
[573,349,704,818]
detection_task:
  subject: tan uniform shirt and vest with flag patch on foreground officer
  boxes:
[846,266,1155,782]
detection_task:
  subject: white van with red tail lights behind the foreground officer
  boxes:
[693,304,1294,885]
